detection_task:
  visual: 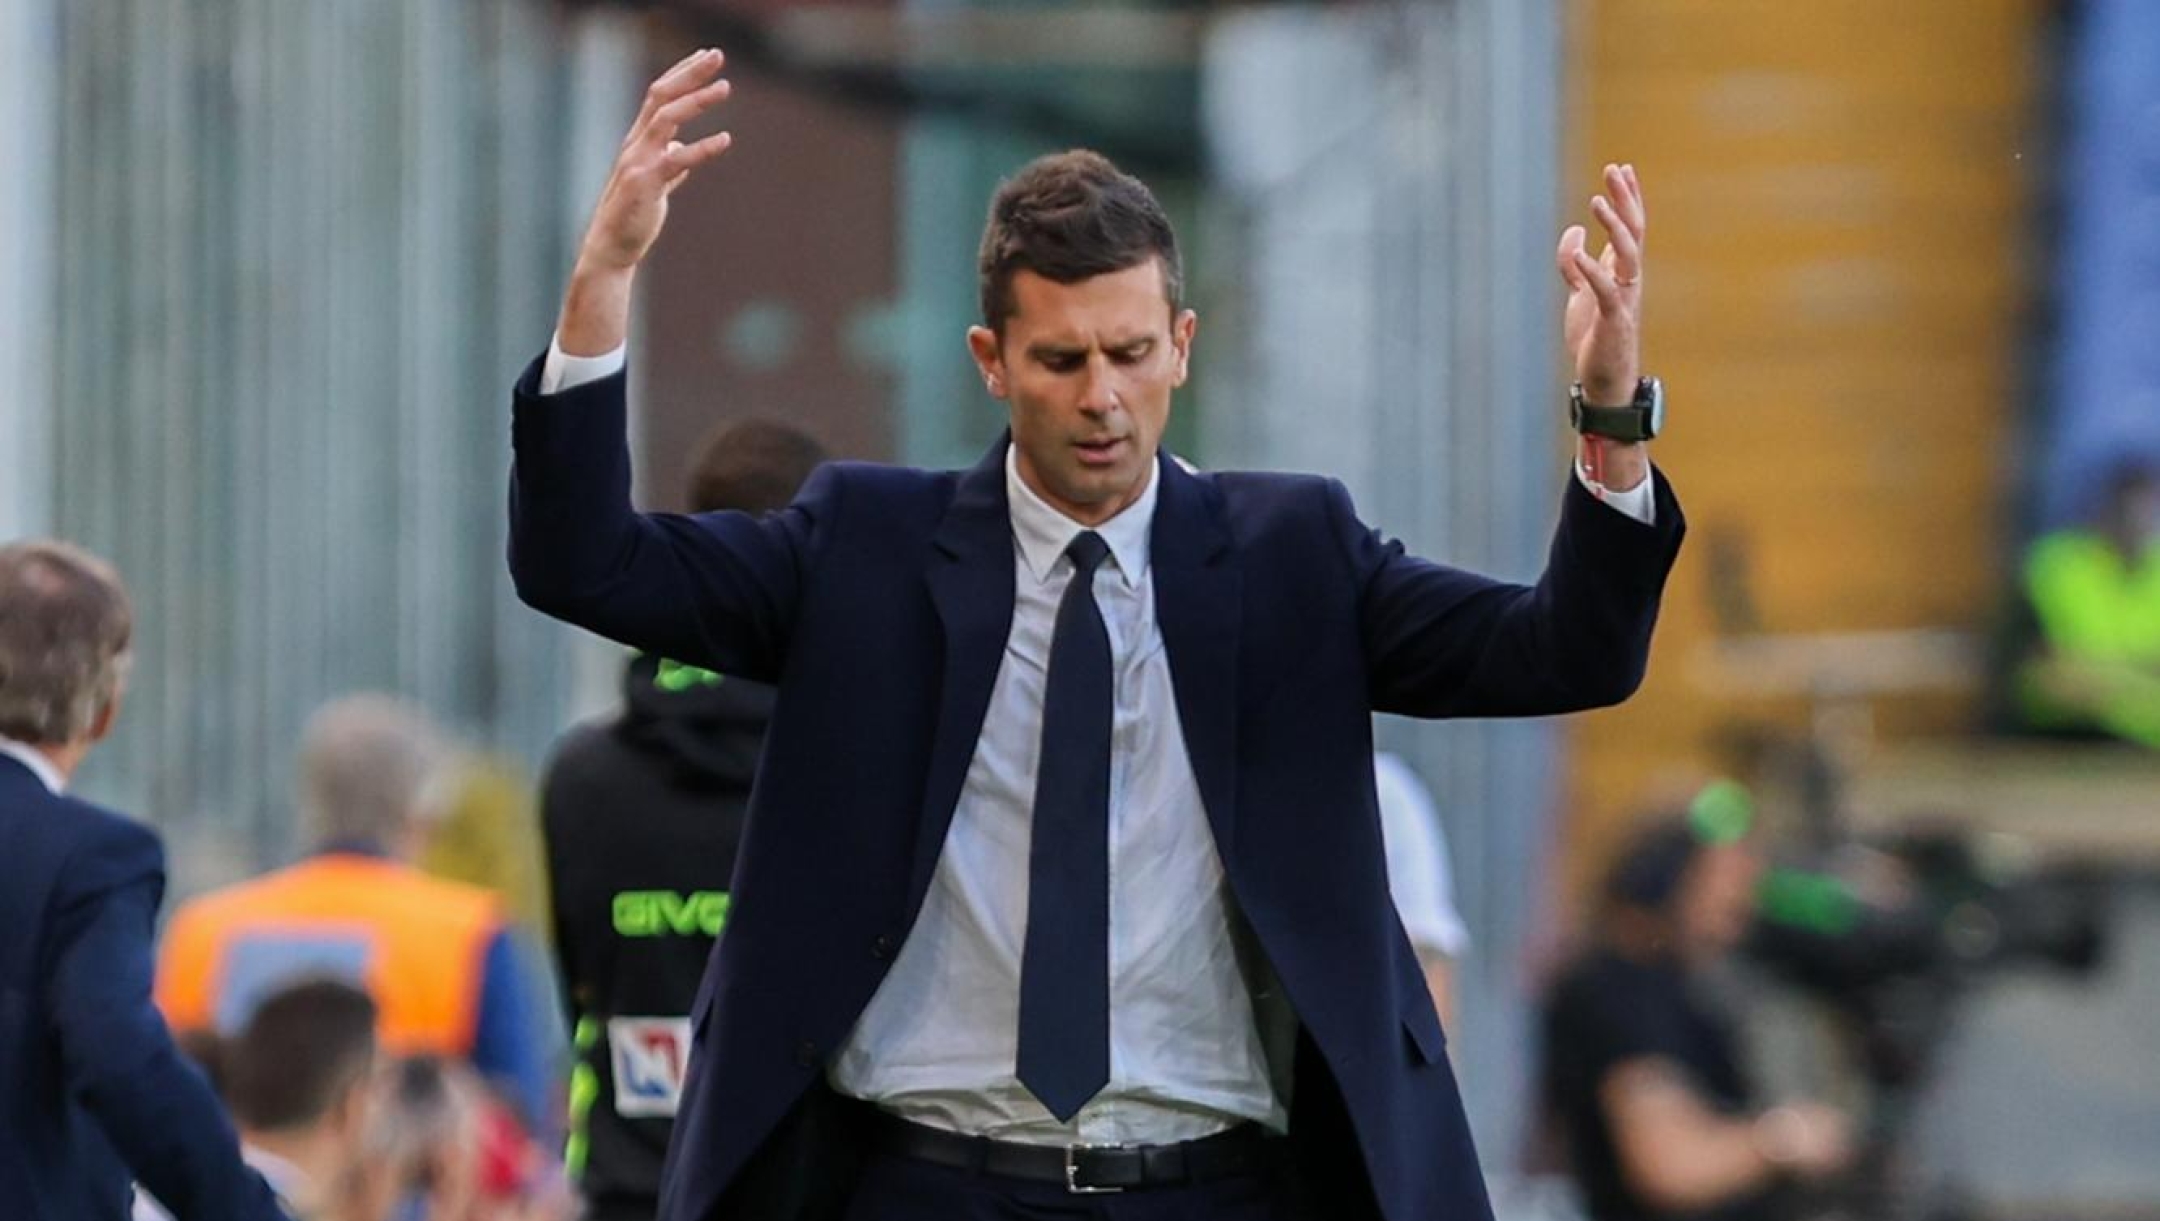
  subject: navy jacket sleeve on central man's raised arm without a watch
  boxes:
[510,361,840,683]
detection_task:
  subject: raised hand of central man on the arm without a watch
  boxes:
[555,50,730,357]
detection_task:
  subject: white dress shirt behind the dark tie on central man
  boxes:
[832,452,1287,1143]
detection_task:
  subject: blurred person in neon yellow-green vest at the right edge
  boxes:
[2020,460,2160,748]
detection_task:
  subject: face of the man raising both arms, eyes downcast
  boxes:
[968,259,1199,525]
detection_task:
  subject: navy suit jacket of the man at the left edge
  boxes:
[0,756,283,1221]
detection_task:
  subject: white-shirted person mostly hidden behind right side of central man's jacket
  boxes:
[1372,750,1471,1024]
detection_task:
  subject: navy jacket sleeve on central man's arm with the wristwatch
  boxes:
[1328,473,1687,717]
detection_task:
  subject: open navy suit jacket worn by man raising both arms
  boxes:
[510,360,1680,1221]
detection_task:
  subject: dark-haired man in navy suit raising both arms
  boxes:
[510,52,1680,1221]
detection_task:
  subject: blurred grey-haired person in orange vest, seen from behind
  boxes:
[158,694,555,1122]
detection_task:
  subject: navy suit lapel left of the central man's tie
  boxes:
[907,434,1013,903]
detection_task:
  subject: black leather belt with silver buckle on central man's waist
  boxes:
[870,1111,1279,1195]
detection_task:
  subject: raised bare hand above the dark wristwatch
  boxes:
[1557,164,1644,406]
